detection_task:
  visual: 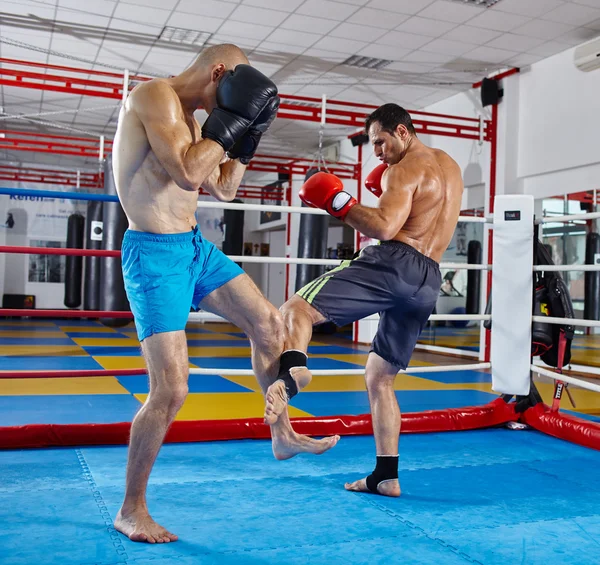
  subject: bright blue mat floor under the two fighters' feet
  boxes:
[0,429,600,565]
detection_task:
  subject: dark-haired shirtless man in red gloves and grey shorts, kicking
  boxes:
[265,104,463,496]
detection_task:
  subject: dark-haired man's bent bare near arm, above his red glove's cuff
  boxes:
[345,164,418,241]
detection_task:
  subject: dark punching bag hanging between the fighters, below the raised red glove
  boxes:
[296,169,329,290]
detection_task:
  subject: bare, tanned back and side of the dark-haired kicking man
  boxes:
[393,146,463,263]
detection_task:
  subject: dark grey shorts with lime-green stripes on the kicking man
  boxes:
[297,240,442,369]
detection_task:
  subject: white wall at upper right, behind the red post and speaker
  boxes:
[425,43,600,205]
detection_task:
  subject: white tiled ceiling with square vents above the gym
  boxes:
[0,0,600,176]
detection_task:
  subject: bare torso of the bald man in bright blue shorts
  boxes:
[113,81,201,233]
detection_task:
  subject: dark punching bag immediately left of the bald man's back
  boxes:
[100,155,131,328]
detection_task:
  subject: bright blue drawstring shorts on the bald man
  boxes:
[121,226,244,342]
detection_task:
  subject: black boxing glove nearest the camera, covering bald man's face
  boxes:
[202,65,277,151]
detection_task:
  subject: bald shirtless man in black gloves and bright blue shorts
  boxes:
[113,45,333,543]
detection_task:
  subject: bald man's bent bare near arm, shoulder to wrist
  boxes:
[131,81,225,191]
